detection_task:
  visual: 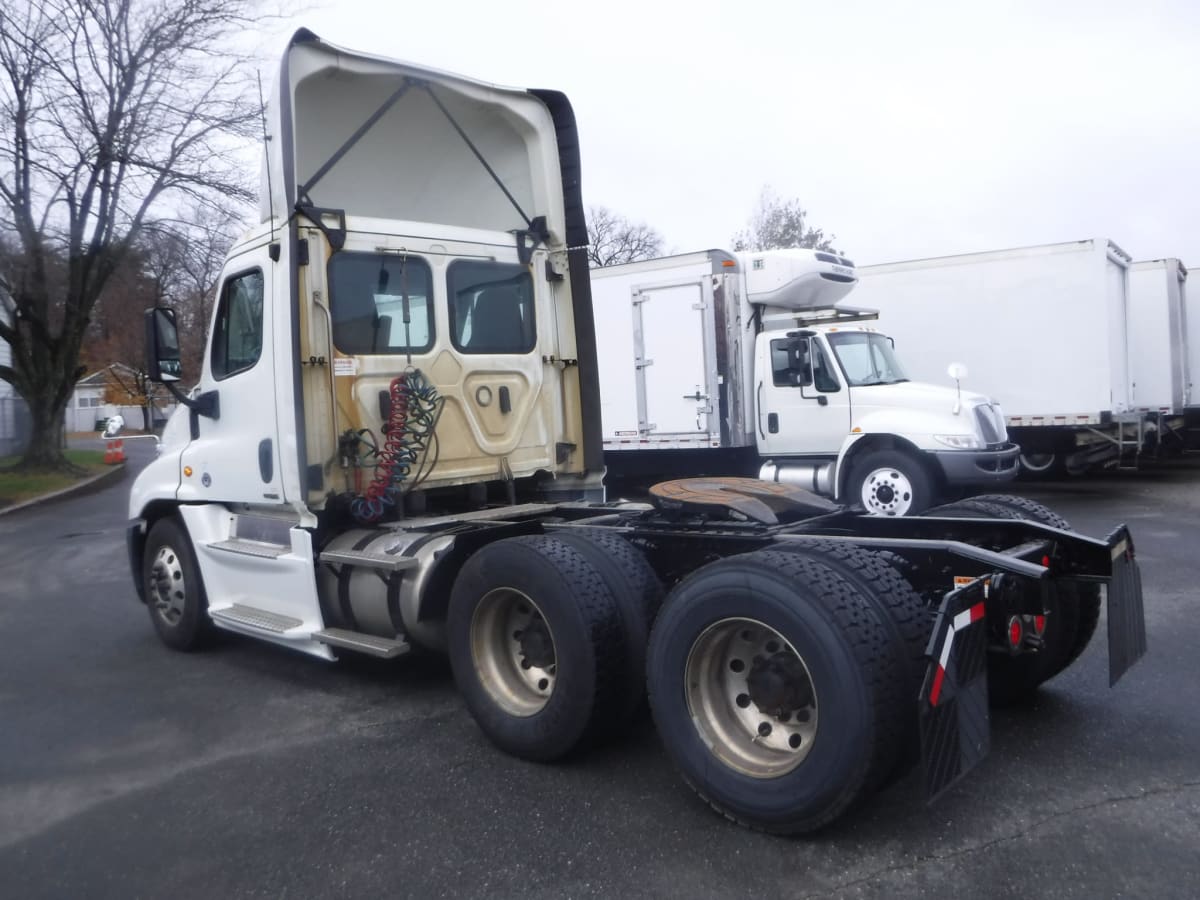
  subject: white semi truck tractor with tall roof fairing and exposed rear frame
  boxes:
[127,31,1145,833]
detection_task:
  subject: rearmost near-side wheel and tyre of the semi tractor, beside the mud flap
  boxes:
[647,550,912,834]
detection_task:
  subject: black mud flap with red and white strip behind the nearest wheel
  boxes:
[917,578,991,803]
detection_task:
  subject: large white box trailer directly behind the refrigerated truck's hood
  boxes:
[856,239,1148,473]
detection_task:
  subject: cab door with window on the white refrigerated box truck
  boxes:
[755,332,850,456]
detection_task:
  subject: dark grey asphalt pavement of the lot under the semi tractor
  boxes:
[0,451,1200,899]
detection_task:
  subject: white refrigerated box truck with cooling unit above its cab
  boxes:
[592,250,1019,515]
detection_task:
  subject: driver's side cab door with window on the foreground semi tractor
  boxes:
[179,244,283,504]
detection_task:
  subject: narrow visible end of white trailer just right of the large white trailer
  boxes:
[1129,259,1192,450]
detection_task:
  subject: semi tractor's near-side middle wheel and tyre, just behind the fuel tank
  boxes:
[446,535,628,761]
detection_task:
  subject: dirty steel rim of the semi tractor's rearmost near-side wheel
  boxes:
[684,618,817,779]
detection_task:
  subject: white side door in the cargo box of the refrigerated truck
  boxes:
[634,278,720,439]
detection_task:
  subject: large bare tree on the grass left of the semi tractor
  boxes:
[0,0,258,468]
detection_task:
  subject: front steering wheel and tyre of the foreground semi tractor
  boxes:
[142,517,212,650]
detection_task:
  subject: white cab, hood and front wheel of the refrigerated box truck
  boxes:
[755,310,1020,515]
